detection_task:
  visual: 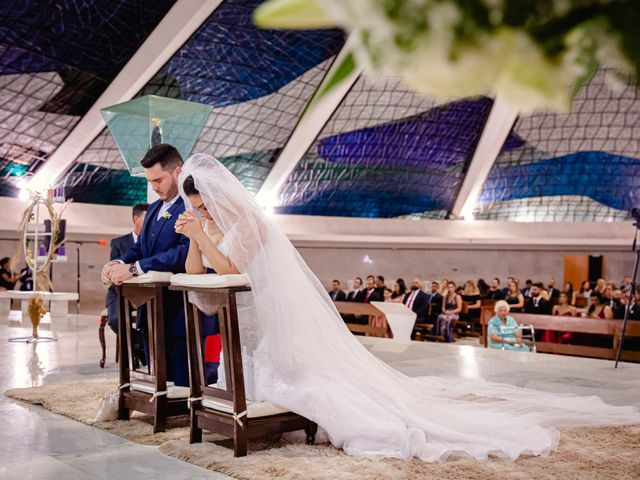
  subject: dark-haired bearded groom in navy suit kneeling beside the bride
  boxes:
[102,144,189,386]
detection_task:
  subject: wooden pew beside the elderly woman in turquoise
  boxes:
[482,313,640,362]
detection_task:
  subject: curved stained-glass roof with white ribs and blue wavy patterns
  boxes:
[0,0,640,222]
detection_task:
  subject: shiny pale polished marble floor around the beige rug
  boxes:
[0,315,640,480]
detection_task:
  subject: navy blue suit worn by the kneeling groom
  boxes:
[120,198,189,386]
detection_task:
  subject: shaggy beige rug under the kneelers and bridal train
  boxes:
[5,380,640,480]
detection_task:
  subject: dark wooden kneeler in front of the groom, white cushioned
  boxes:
[118,282,189,433]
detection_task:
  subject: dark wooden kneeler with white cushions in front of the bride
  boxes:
[170,284,317,457]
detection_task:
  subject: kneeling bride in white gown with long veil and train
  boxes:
[176,154,640,461]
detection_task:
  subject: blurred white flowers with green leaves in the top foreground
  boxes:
[258,0,632,113]
